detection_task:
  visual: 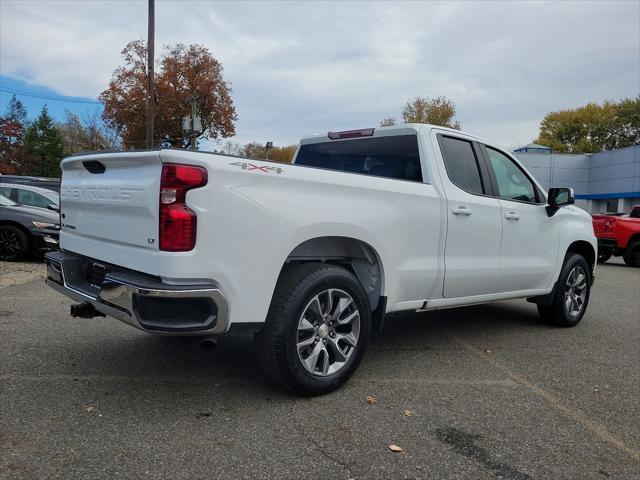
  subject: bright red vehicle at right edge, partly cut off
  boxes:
[593,205,640,267]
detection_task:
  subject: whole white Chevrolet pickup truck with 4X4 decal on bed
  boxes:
[46,124,597,395]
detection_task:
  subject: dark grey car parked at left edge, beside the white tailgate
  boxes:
[0,195,60,261]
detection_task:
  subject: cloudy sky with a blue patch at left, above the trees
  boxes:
[0,0,640,150]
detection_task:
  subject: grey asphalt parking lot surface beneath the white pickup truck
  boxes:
[0,260,640,479]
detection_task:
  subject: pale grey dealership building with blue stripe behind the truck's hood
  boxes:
[513,144,640,213]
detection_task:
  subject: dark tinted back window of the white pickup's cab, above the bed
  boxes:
[296,135,422,182]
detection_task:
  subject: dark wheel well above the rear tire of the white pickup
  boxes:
[283,237,384,310]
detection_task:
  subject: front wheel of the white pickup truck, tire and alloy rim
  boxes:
[538,253,591,327]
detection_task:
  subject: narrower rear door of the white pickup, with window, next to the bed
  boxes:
[434,133,502,298]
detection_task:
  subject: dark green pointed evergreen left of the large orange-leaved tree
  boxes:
[24,105,64,177]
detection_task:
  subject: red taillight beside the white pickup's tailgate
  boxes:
[159,163,207,252]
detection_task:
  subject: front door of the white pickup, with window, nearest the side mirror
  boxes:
[482,145,559,292]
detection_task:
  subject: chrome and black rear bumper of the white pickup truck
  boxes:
[45,251,229,335]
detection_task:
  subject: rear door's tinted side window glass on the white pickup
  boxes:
[440,136,483,194]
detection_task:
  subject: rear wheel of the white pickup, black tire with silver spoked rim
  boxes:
[256,263,371,396]
